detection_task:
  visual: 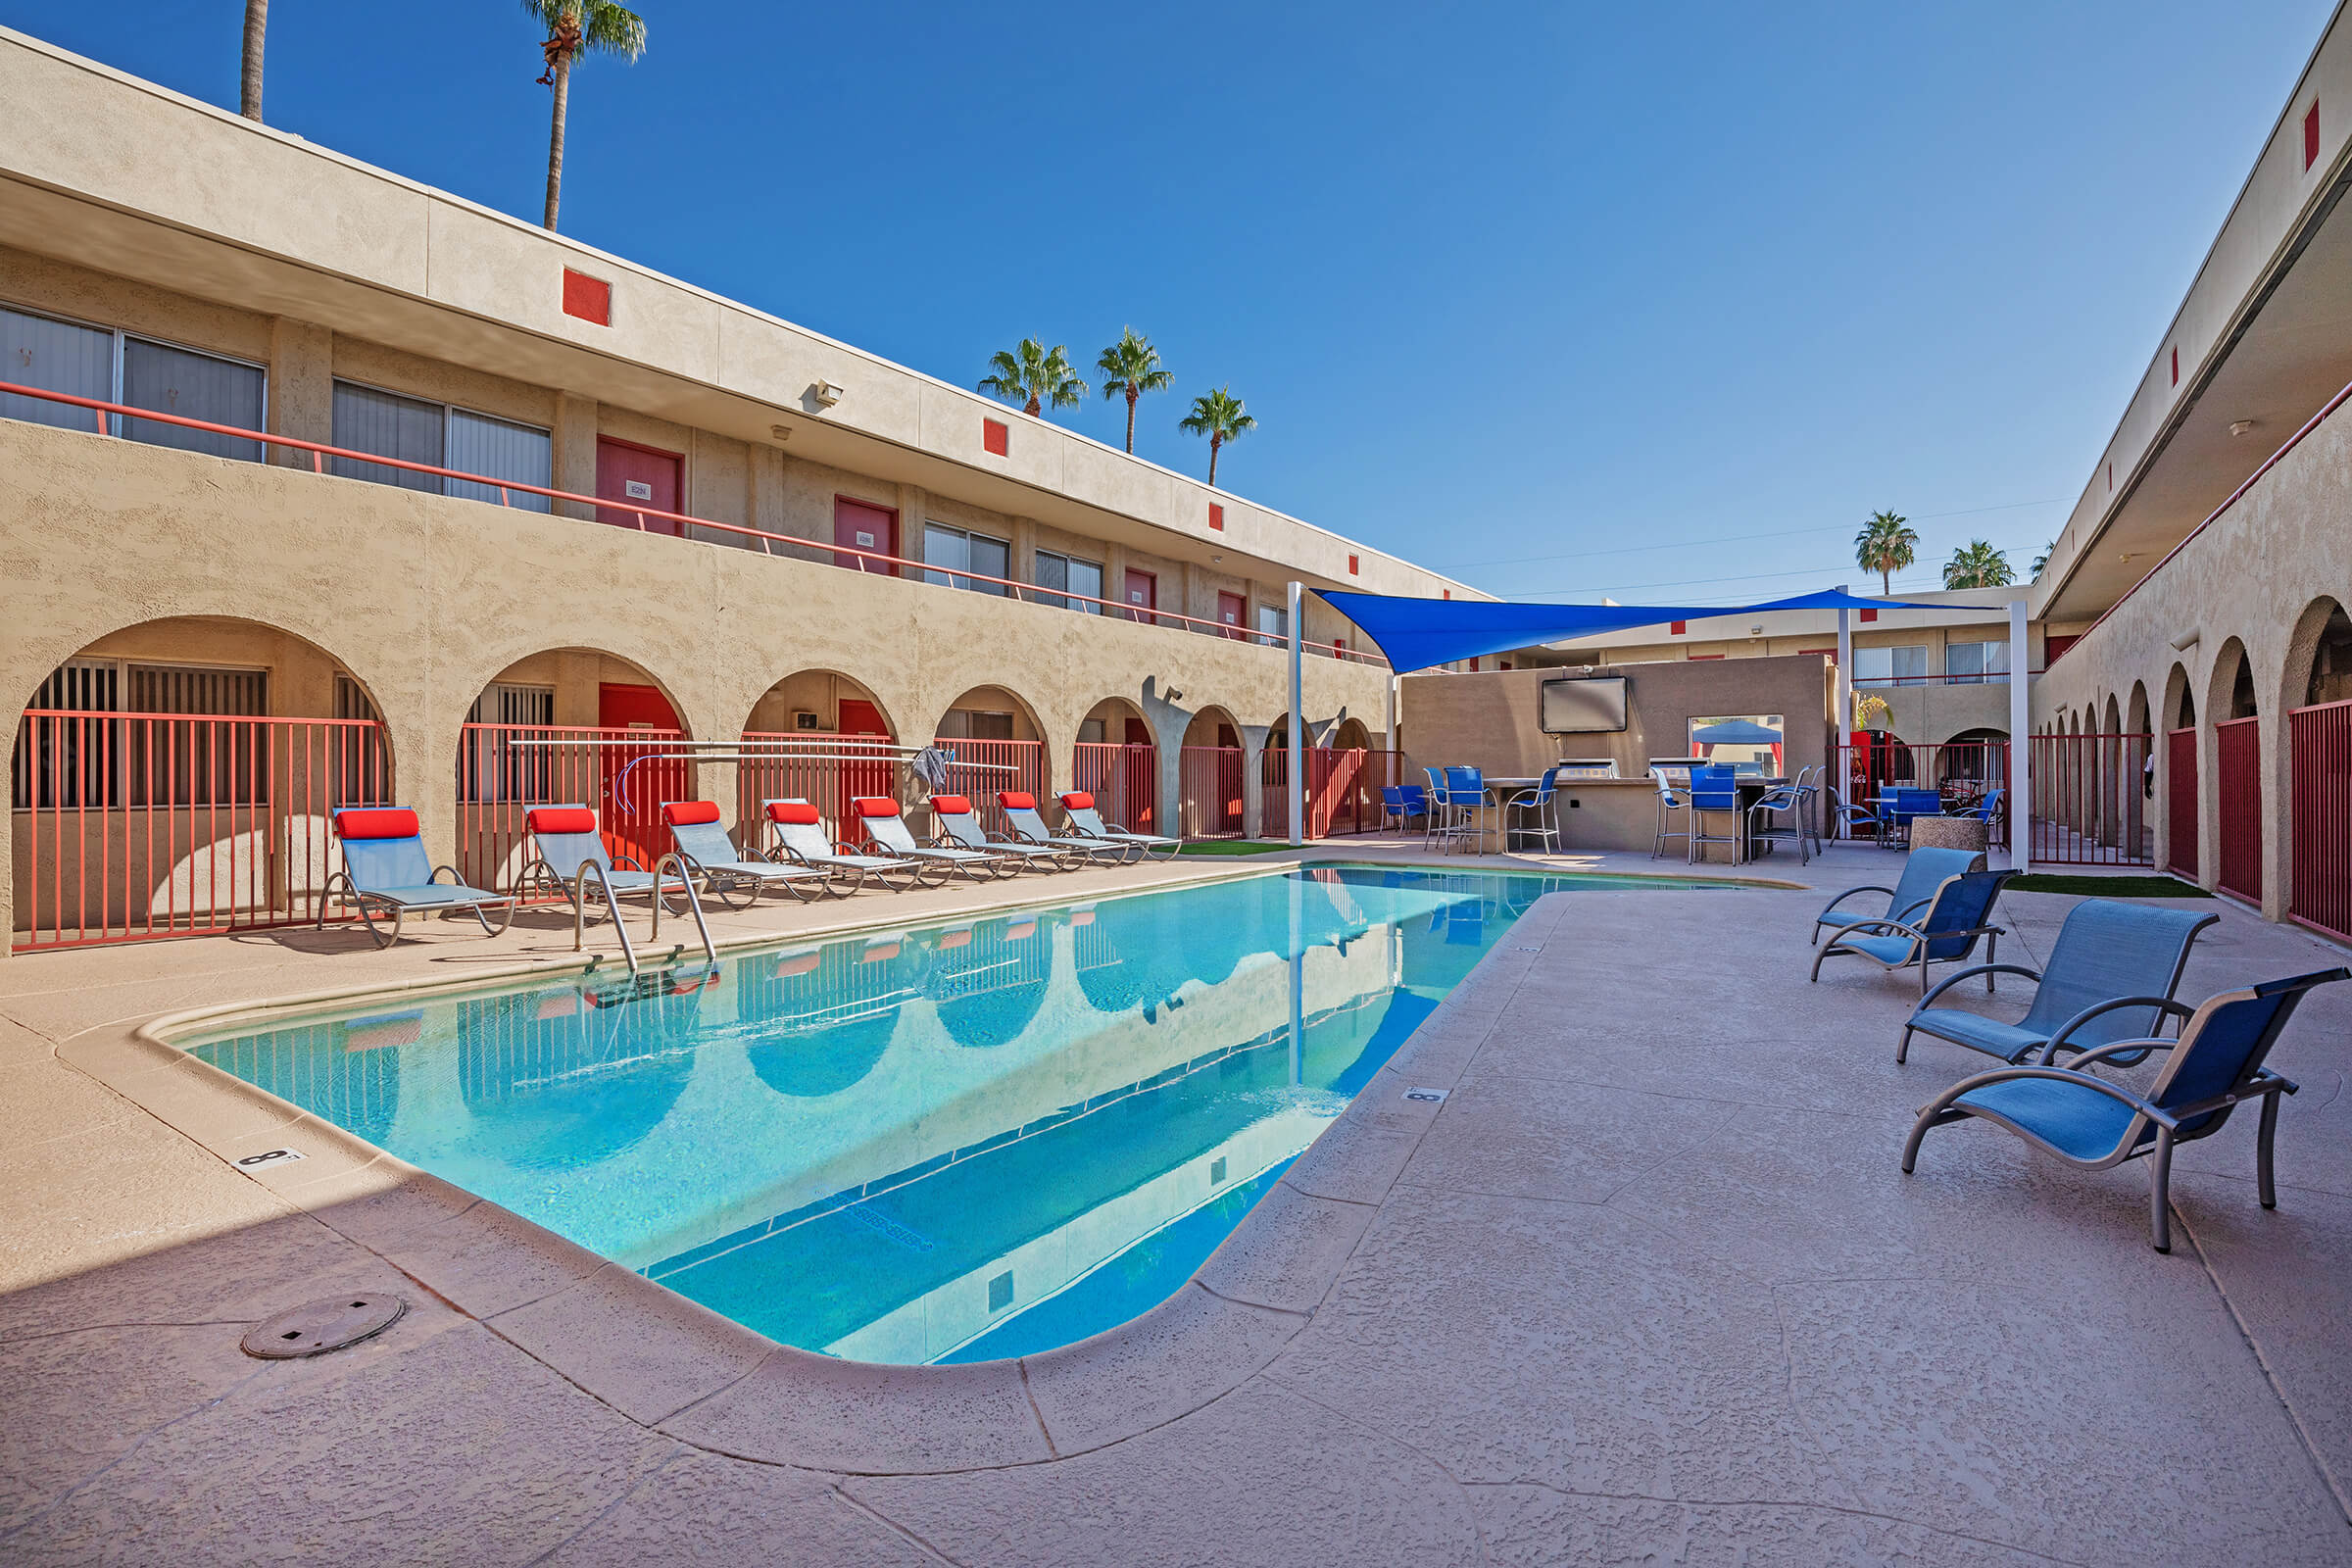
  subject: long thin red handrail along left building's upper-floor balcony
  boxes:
[0,381,1388,667]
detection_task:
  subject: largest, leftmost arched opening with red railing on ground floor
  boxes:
[10,615,395,948]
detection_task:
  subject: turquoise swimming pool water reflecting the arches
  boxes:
[188,867,1731,1361]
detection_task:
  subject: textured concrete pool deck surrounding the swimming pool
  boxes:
[0,842,2352,1563]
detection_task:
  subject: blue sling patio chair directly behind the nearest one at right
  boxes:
[1895,903,2221,1067]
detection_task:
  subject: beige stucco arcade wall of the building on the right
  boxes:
[2033,387,2352,919]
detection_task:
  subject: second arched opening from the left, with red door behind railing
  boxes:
[457,649,694,889]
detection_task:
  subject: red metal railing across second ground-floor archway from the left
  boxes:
[457,724,696,891]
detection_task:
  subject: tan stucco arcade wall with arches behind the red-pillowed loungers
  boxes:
[0,420,1388,950]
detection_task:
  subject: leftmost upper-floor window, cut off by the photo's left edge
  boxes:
[0,311,269,464]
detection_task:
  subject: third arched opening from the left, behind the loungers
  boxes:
[736,670,899,847]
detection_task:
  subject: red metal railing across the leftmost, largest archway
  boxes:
[10,708,393,950]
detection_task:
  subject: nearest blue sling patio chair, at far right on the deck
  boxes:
[1903,968,2352,1253]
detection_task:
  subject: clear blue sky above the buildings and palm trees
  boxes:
[0,0,2333,602]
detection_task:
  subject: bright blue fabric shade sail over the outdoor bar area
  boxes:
[1315,588,1950,674]
